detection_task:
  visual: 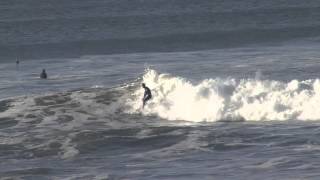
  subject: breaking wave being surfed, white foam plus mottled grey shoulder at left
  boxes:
[0,69,320,124]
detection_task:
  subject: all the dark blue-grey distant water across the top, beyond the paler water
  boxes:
[0,0,320,61]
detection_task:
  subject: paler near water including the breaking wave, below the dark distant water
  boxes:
[0,42,320,180]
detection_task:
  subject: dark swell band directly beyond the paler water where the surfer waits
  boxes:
[0,26,320,60]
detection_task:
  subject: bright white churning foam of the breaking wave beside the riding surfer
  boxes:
[127,70,320,122]
